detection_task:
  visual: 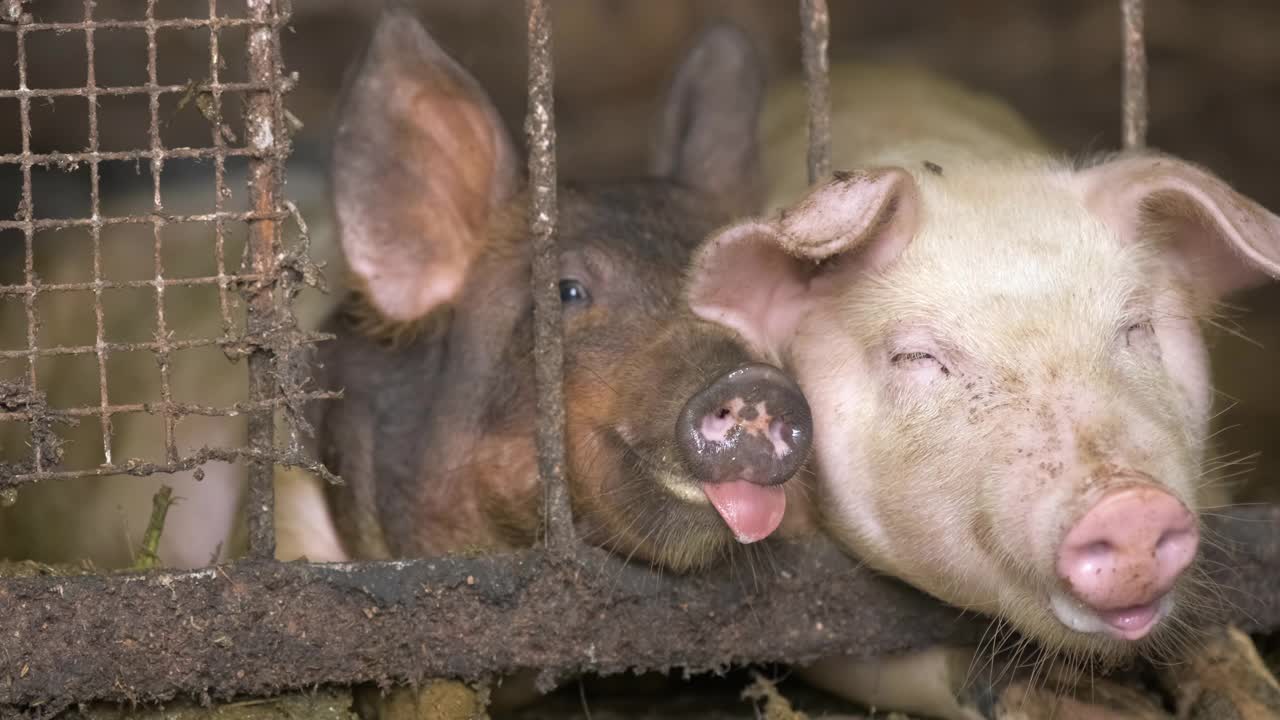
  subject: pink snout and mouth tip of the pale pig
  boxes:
[1057,486,1199,641]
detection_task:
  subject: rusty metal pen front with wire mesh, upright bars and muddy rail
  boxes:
[0,0,1280,717]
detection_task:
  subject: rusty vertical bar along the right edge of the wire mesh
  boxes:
[244,0,284,560]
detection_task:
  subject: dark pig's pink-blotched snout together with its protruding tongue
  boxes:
[676,363,813,543]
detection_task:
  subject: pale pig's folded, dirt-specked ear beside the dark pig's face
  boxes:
[687,168,919,354]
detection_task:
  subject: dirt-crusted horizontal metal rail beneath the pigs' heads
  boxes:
[0,507,1280,710]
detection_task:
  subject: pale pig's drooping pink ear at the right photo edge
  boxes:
[1078,154,1280,296]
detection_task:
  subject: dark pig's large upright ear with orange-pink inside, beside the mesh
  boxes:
[333,10,517,322]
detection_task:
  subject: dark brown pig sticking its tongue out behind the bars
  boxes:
[280,13,812,571]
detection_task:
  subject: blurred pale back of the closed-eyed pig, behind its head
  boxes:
[760,63,1048,211]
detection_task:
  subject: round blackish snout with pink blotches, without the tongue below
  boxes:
[676,363,813,486]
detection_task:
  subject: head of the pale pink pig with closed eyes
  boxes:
[690,143,1280,659]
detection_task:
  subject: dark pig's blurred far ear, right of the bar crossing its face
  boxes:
[652,23,765,215]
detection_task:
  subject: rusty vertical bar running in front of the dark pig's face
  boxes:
[525,0,573,551]
